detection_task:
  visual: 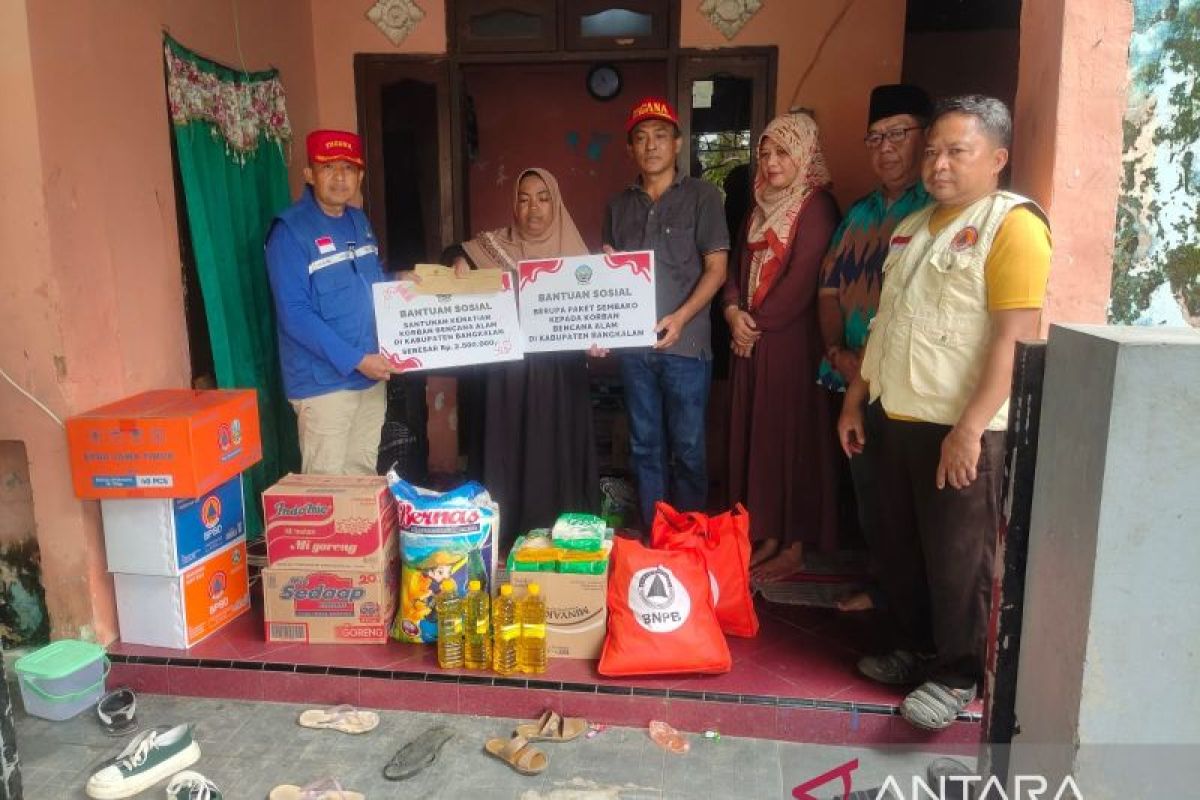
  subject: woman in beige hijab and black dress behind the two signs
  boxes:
[456,168,600,552]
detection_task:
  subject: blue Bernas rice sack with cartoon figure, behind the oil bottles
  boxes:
[388,473,500,643]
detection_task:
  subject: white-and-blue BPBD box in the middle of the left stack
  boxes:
[100,475,246,576]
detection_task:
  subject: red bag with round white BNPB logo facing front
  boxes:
[598,537,732,678]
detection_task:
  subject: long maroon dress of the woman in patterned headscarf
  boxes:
[724,191,839,551]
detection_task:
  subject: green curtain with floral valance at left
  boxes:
[164,37,300,539]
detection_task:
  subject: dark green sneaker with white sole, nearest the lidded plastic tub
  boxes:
[88,724,200,800]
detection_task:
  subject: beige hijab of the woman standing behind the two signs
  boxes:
[462,167,588,272]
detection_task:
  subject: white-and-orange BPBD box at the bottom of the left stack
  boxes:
[113,537,250,650]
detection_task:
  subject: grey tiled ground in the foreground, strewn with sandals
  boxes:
[17,696,971,800]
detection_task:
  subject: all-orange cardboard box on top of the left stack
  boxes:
[66,389,263,500]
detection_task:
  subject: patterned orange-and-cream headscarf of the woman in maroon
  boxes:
[746,114,832,311]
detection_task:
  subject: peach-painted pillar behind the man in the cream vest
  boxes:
[1013,0,1133,331]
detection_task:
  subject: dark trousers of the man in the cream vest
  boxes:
[876,417,1004,688]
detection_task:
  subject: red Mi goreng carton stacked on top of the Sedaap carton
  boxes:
[263,475,398,572]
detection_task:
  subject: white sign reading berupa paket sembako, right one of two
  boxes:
[517,251,658,353]
